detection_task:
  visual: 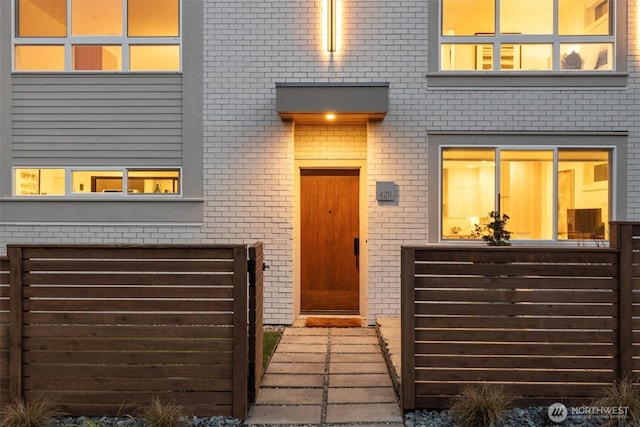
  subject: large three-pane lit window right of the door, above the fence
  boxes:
[441,147,611,241]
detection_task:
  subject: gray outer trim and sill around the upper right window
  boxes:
[425,0,628,88]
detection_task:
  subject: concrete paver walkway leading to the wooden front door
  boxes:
[245,327,404,427]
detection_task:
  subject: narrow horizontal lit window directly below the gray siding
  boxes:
[14,168,181,196]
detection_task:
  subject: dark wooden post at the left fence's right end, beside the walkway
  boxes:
[232,246,249,420]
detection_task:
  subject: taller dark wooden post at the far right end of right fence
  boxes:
[612,222,633,379]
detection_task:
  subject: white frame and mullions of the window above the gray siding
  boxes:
[11,0,183,73]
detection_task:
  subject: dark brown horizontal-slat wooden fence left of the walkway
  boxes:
[0,244,262,419]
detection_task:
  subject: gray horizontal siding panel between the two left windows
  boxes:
[11,74,183,166]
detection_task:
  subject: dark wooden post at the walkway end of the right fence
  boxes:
[400,247,416,410]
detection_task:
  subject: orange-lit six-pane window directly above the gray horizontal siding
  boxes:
[13,0,181,71]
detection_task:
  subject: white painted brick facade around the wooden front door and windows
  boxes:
[0,0,640,324]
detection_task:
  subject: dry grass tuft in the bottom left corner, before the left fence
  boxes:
[0,397,63,427]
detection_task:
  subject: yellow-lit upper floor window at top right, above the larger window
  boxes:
[440,0,615,71]
